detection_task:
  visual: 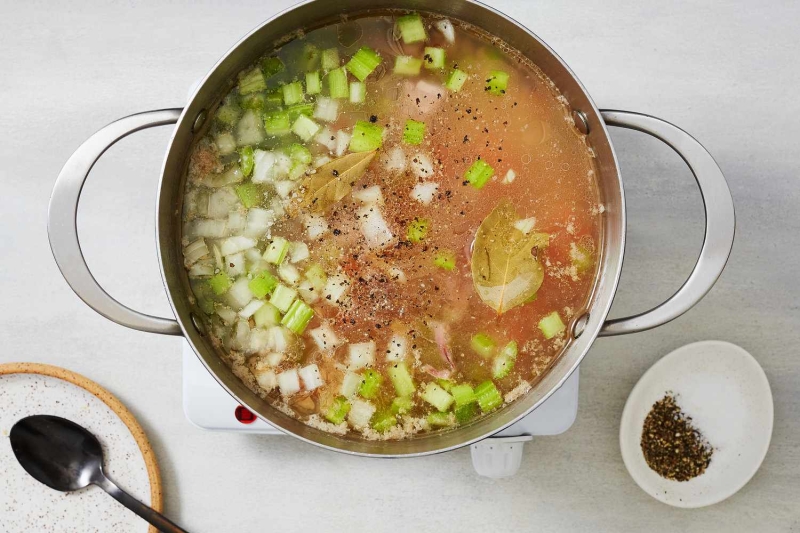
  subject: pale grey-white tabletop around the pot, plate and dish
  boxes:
[0,0,800,532]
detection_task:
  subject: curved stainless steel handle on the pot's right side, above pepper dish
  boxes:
[599,110,736,337]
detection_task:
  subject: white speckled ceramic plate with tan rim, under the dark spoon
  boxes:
[0,363,163,533]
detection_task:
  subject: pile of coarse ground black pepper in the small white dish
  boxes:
[641,392,714,481]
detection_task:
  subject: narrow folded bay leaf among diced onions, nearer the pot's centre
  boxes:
[302,150,375,213]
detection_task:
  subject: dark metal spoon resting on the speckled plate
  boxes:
[11,415,187,533]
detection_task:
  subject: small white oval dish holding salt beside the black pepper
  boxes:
[619,341,773,508]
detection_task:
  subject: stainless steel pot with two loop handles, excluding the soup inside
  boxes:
[48,0,734,457]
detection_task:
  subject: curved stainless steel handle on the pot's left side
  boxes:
[47,109,183,335]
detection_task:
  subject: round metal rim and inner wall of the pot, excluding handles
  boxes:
[156,0,625,456]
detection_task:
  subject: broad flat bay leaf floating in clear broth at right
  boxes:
[472,199,550,315]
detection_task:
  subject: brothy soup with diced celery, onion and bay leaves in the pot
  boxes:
[182,13,603,439]
